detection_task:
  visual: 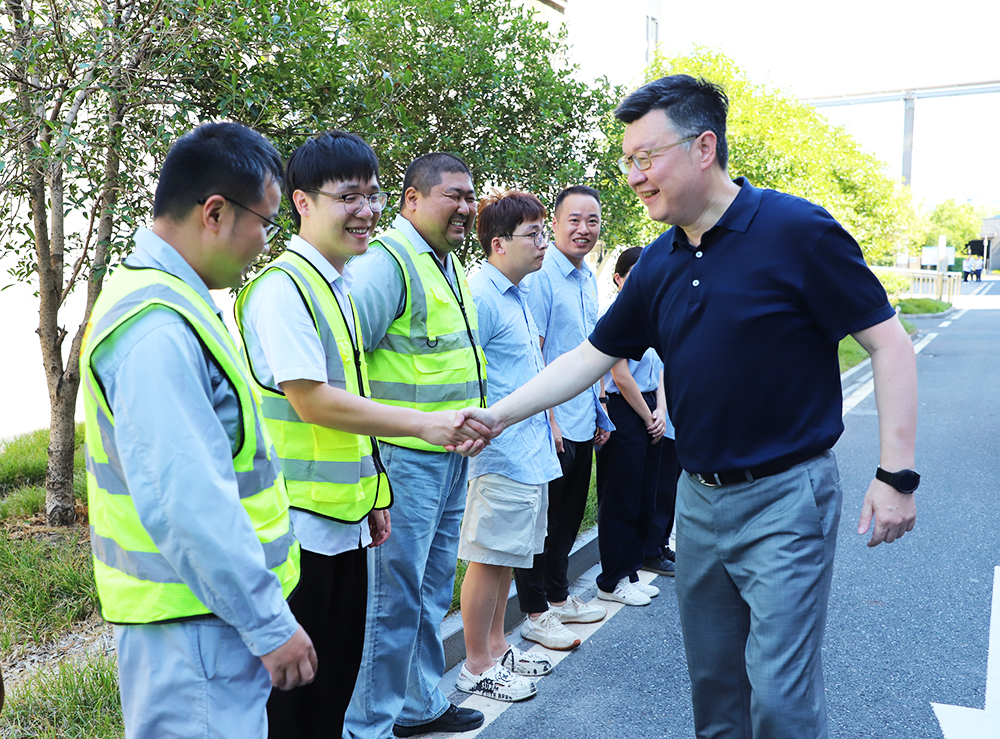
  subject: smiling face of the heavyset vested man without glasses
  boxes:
[403,172,476,257]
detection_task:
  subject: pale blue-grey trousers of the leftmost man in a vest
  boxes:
[115,618,271,739]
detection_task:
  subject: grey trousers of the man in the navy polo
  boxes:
[676,451,841,739]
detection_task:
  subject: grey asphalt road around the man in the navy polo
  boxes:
[442,281,1000,739]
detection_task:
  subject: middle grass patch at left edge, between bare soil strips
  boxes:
[0,530,97,653]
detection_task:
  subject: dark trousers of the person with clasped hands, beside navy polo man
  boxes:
[597,392,663,593]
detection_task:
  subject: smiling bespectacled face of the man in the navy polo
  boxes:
[622,110,703,227]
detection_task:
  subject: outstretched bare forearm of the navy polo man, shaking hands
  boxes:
[491,341,617,428]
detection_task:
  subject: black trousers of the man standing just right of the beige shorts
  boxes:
[514,439,594,613]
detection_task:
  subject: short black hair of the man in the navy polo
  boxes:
[615,74,729,170]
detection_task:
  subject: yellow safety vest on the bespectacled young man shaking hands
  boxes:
[236,250,392,523]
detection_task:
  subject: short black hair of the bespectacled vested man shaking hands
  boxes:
[285,131,378,227]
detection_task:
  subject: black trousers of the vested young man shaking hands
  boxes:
[267,549,368,739]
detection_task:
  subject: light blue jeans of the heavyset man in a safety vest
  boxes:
[344,444,468,739]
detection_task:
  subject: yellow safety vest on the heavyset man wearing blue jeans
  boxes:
[367,228,486,452]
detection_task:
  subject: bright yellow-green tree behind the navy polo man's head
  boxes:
[646,47,919,264]
